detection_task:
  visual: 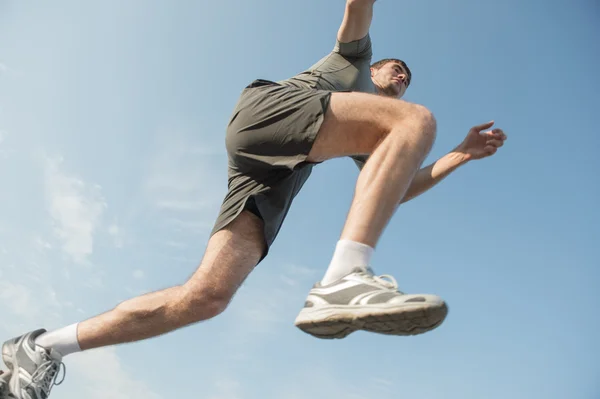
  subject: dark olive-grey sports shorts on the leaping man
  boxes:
[212,80,331,258]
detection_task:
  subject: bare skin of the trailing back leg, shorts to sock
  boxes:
[77,211,265,350]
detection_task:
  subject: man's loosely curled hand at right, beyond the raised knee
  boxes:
[456,121,506,160]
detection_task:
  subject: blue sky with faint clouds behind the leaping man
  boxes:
[0,0,600,399]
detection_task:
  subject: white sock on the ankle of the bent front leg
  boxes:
[321,240,375,285]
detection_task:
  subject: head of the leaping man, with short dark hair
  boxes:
[371,58,412,98]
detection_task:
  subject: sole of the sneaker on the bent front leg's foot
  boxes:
[295,302,448,339]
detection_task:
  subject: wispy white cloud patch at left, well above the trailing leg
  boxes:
[45,159,106,263]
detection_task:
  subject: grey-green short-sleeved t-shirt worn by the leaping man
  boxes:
[278,34,376,169]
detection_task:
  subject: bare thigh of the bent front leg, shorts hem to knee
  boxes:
[307,92,424,162]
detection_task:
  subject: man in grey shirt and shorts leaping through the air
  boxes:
[2,0,506,399]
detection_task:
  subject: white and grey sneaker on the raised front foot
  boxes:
[295,268,448,339]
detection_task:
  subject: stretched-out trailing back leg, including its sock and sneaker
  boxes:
[2,211,265,399]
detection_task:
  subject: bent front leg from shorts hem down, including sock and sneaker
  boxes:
[295,93,448,339]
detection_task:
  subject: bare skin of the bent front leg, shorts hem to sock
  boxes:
[309,93,436,247]
